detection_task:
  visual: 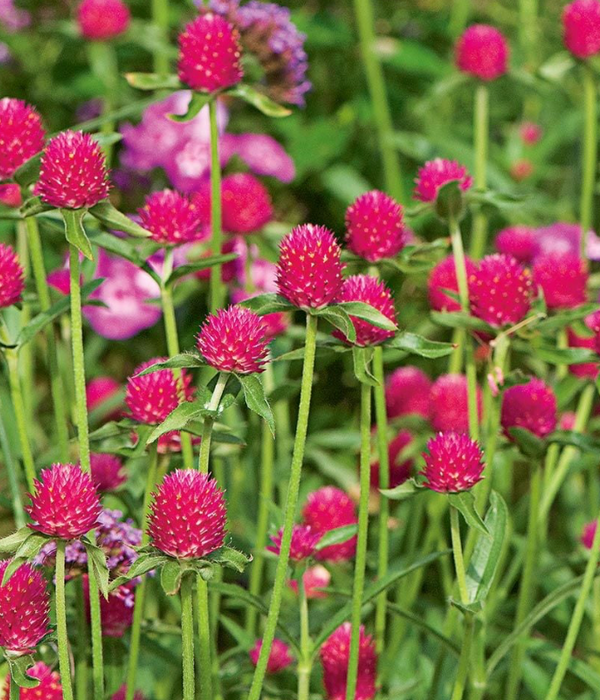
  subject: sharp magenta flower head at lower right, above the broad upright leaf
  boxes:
[422,432,484,493]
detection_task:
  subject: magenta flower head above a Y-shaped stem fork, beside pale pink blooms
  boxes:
[138,190,203,245]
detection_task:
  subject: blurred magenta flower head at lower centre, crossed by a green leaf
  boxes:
[302,486,358,561]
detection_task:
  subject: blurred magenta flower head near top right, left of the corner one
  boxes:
[456,24,509,81]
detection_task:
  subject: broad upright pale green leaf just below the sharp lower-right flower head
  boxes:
[467,491,508,602]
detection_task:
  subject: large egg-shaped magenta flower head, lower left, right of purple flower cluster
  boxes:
[148,469,227,559]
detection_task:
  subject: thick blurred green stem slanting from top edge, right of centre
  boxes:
[354,0,404,201]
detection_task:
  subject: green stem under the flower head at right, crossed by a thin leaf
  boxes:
[506,464,542,700]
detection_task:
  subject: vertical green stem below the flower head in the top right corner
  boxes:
[579,64,598,260]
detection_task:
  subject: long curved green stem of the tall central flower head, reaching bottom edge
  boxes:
[248,315,318,700]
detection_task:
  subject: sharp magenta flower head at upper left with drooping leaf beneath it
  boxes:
[35,131,109,209]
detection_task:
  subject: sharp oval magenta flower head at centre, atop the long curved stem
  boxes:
[277,224,344,309]
